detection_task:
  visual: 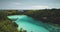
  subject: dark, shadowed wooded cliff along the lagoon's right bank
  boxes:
[24,9,60,24]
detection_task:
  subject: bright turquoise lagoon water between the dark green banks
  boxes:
[8,15,60,32]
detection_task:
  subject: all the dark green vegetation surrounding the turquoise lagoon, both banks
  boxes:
[0,9,60,32]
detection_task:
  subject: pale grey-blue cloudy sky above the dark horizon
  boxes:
[0,0,60,9]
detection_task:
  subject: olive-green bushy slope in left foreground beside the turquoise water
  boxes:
[0,11,18,32]
